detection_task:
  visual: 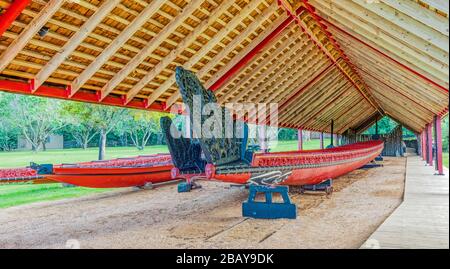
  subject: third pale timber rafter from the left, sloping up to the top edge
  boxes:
[70,0,165,95]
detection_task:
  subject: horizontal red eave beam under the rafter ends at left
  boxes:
[0,79,164,112]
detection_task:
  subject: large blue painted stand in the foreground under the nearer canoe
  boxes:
[242,185,297,219]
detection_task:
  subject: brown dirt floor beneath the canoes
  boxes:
[0,158,406,248]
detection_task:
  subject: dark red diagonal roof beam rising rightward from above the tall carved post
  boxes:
[209,14,294,91]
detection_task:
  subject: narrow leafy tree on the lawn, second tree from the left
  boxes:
[63,102,99,149]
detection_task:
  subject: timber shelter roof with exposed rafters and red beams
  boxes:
[0,0,449,133]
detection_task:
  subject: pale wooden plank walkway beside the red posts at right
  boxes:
[361,156,449,249]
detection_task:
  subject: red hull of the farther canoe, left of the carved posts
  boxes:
[45,154,173,188]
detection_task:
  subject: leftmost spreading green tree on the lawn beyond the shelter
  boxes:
[8,95,67,152]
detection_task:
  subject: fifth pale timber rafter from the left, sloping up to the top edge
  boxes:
[125,1,234,103]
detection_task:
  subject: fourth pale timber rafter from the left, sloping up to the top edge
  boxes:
[101,0,203,99]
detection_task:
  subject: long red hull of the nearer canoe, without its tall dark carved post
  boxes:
[205,141,384,185]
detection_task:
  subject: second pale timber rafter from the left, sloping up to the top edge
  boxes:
[33,0,120,90]
